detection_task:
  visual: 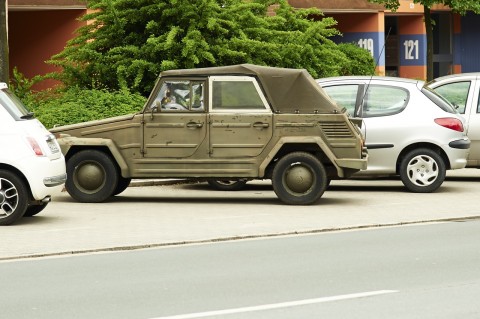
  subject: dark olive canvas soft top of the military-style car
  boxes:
[160,64,340,114]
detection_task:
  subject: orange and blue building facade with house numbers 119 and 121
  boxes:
[289,0,480,79]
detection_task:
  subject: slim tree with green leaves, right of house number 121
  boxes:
[369,0,480,81]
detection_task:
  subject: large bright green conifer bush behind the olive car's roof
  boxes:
[50,0,374,95]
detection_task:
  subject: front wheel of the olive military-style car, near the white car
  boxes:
[65,150,120,203]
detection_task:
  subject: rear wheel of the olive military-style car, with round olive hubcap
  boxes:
[272,152,328,205]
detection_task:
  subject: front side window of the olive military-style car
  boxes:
[155,81,205,112]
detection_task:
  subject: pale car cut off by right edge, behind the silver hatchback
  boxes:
[427,73,480,168]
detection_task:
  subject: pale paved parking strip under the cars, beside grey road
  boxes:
[0,169,480,260]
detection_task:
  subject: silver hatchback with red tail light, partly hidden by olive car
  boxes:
[317,76,470,193]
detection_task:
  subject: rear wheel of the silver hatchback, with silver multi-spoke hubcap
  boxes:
[400,148,446,193]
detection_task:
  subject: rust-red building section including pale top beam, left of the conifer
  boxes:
[7,0,87,90]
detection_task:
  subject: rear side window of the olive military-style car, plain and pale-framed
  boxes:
[212,79,265,111]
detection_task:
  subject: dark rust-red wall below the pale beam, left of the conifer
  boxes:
[8,10,85,89]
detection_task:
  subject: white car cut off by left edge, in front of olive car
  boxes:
[0,82,67,225]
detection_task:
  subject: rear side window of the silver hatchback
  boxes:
[362,85,409,117]
